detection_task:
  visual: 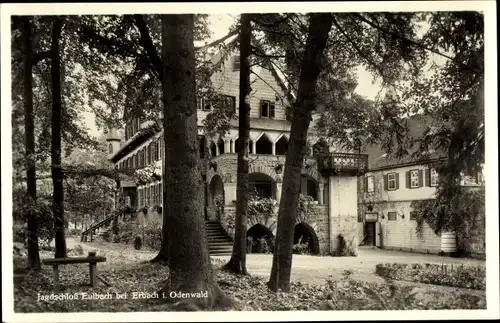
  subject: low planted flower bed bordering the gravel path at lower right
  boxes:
[375,263,486,290]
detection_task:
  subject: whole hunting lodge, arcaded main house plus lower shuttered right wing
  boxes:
[102,47,484,254]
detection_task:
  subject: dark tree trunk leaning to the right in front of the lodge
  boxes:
[268,13,332,292]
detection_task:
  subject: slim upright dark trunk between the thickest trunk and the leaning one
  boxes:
[225,14,252,275]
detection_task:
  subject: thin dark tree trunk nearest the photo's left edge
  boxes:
[23,17,41,270]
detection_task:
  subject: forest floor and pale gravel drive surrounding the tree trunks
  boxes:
[14,237,486,312]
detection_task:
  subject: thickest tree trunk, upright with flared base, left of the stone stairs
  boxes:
[160,15,232,309]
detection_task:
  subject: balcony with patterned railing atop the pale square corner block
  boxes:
[318,153,368,175]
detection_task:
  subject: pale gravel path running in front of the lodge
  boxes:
[67,237,485,293]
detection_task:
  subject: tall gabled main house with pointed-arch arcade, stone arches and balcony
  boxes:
[108,45,367,254]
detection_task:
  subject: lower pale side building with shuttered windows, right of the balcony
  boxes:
[357,118,485,255]
